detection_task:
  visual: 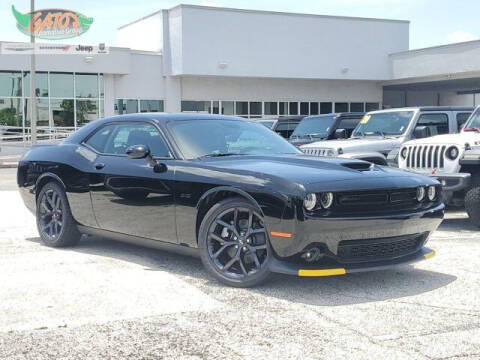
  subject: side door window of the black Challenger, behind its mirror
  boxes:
[103,124,170,157]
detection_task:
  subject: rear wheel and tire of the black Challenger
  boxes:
[36,182,82,247]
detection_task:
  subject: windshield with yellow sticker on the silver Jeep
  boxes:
[353,111,413,137]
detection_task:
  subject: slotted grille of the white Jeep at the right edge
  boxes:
[406,145,447,170]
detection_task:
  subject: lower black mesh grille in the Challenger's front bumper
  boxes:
[338,234,427,263]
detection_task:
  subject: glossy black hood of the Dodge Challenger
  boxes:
[201,155,424,185]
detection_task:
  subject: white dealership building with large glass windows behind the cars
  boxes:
[0,5,480,127]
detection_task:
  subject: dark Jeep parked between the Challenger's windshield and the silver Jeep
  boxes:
[289,112,365,147]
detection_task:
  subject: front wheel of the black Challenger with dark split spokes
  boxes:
[198,197,273,287]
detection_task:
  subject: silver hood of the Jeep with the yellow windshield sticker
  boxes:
[300,136,400,153]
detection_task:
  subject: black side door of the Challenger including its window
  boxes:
[85,122,177,243]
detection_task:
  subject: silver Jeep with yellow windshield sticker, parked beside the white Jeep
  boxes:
[301,106,473,165]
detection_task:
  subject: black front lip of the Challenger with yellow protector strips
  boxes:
[270,247,435,277]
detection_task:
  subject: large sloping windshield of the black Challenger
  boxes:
[168,119,301,159]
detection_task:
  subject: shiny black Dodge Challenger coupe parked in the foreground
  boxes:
[18,113,444,286]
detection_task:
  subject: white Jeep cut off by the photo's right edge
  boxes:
[398,107,480,227]
